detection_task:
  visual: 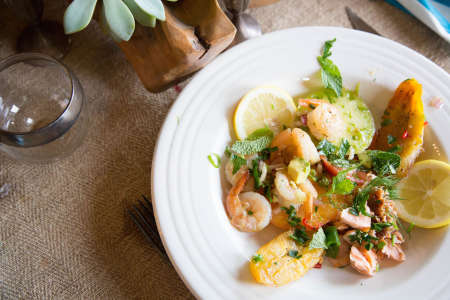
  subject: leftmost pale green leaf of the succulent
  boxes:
[64,0,97,34]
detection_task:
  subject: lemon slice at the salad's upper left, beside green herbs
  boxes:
[233,86,297,140]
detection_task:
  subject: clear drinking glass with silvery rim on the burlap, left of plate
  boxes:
[0,53,89,162]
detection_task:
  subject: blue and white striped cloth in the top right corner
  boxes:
[385,0,450,43]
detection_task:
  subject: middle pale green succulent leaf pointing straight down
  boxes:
[102,0,135,41]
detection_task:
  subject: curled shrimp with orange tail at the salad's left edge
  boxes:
[225,172,272,232]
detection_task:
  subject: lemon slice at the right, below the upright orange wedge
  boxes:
[396,160,450,228]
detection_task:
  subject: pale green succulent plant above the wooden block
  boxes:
[64,0,177,42]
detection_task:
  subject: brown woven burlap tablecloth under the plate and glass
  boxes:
[0,0,450,299]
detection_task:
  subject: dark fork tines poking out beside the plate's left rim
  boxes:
[128,195,170,263]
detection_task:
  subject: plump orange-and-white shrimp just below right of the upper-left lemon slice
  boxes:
[270,128,320,164]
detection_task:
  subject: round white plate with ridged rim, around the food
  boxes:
[152,27,450,300]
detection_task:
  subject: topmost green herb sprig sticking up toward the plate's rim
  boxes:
[317,39,342,102]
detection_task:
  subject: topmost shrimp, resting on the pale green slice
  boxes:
[307,103,346,143]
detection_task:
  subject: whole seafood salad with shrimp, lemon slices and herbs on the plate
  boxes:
[208,40,450,286]
